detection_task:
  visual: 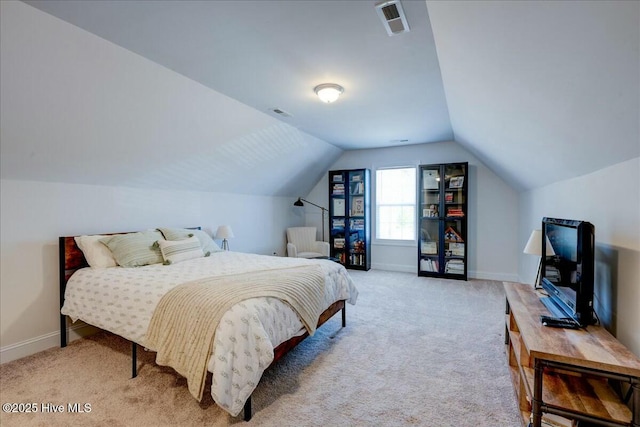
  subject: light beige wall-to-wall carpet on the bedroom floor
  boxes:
[0,270,521,427]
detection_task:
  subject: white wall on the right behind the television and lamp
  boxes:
[518,158,640,356]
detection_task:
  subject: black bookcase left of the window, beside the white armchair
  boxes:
[329,169,371,270]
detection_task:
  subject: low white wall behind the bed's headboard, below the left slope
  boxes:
[0,180,304,362]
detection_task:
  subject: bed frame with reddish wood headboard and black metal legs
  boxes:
[58,234,347,421]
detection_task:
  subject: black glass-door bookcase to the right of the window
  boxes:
[418,163,469,280]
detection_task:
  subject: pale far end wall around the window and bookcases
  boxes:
[306,142,520,280]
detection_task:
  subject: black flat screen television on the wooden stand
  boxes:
[541,217,595,326]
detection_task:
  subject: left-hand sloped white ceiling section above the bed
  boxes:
[0,2,342,196]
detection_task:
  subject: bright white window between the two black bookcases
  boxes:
[376,167,416,240]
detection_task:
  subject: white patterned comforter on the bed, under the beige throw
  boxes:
[62,252,358,416]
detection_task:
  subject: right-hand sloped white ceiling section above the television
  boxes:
[428,1,640,189]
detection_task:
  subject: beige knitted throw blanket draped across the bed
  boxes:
[145,265,324,401]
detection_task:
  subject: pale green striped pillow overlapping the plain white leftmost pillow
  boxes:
[100,231,162,267]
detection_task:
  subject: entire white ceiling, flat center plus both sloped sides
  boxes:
[0,0,640,196]
